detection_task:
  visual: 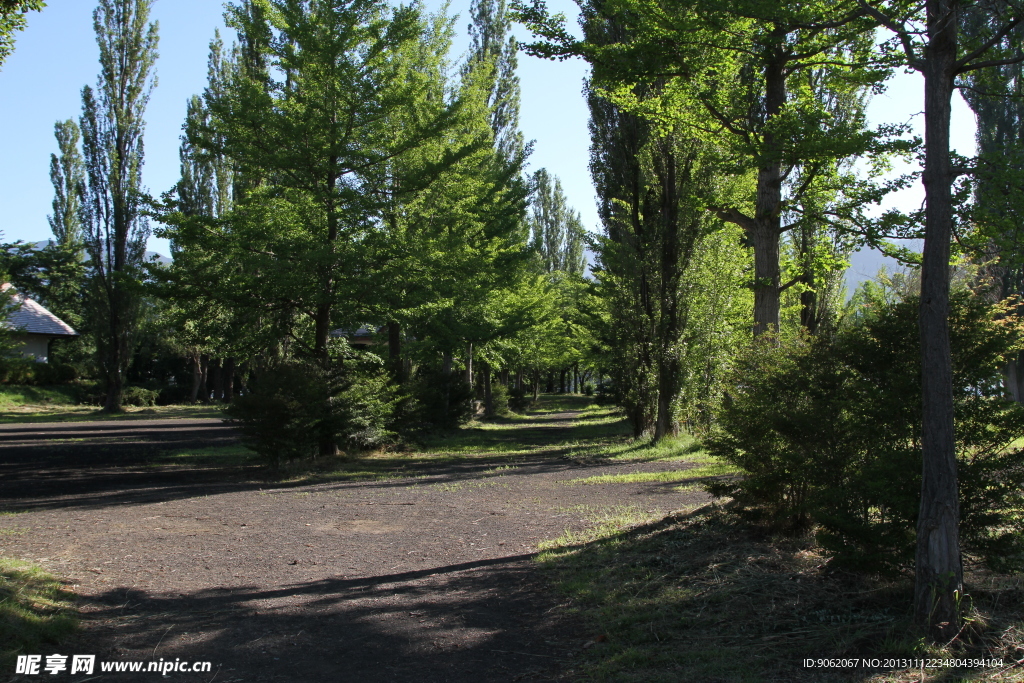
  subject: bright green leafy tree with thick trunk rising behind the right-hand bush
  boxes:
[516,0,904,335]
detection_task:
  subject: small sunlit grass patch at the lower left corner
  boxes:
[0,557,78,672]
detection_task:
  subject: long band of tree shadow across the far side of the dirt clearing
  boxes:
[0,396,696,510]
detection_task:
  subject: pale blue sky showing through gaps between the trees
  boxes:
[0,0,975,283]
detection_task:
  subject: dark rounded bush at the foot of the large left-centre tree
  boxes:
[226,352,395,467]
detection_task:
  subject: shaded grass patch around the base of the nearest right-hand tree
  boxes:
[538,506,1024,683]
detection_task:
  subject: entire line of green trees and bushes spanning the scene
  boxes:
[6,0,1024,639]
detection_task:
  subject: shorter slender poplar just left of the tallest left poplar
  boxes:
[47,119,85,246]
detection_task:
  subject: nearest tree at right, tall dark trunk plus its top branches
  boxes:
[862,0,1024,639]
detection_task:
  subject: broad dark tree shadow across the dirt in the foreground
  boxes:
[27,555,584,683]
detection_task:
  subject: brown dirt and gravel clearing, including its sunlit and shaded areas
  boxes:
[0,412,705,683]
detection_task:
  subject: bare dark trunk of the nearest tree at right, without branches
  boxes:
[914,0,964,640]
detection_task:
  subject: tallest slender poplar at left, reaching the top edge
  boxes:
[81,0,158,412]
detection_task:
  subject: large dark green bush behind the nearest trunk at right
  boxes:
[707,294,1024,570]
